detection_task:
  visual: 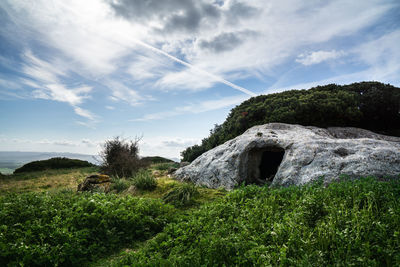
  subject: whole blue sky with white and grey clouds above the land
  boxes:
[0,0,400,158]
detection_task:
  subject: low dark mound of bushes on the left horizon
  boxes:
[14,158,94,173]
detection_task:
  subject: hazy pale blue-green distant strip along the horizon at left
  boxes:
[0,151,99,174]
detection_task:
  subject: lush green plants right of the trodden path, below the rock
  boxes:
[119,179,400,266]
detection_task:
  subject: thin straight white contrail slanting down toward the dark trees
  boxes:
[132,38,257,96]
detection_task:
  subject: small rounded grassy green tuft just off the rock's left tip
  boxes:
[163,183,199,207]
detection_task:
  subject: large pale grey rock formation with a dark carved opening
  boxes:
[174,123,400,190]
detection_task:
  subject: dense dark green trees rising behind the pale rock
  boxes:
[181,82,400,161]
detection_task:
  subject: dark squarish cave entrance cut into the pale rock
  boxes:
[247,146,285,185]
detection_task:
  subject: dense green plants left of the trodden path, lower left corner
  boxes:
[0,191,174,266]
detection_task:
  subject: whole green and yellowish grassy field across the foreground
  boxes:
[0,165,400,266]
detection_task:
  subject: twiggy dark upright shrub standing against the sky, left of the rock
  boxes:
[100,137,145,177]
